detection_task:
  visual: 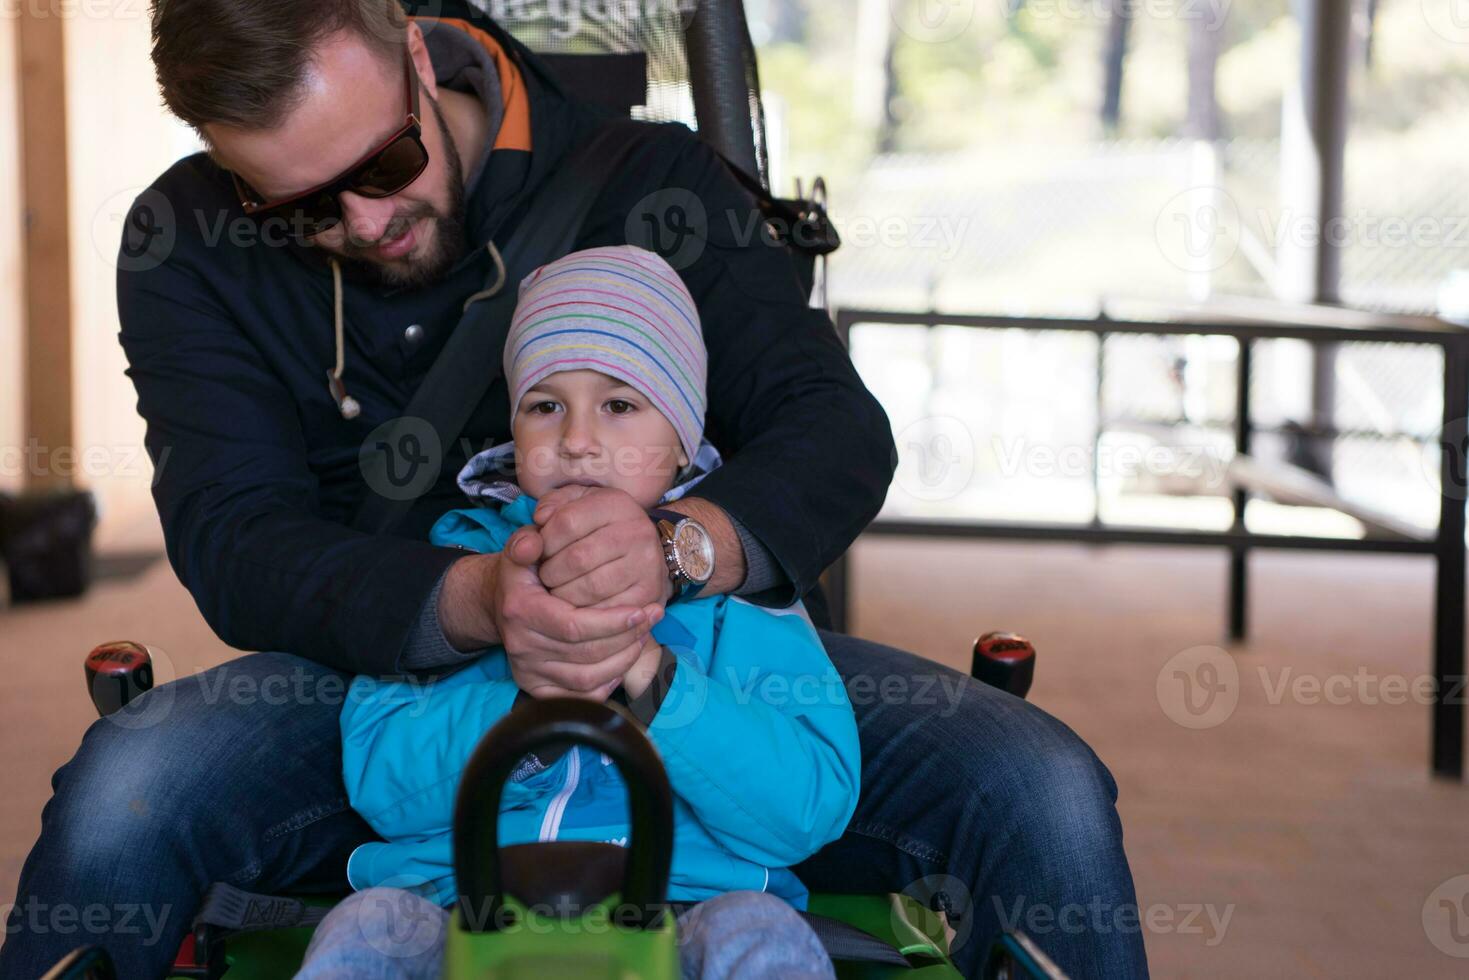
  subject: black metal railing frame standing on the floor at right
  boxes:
[826,309,1469,780]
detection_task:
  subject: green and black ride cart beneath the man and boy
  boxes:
[46,633,1064,980]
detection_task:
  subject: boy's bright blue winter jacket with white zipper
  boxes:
[341,478,861,908]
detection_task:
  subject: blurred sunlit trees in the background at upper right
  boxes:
[749,0,1469,163]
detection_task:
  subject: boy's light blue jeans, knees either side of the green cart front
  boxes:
[295,887,836,980]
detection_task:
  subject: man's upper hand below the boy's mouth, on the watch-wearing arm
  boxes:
[535,486,673,608]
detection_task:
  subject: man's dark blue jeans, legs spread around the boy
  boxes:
[0,633,1147,980]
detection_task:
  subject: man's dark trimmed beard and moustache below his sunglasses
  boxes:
[326,96,469,289]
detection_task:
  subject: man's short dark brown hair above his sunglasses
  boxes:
[153,0,407,132]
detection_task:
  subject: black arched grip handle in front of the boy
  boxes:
[454,698,673,933]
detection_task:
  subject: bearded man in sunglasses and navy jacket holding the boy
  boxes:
[0,0,1146,980]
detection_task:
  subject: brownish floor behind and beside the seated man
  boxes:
[0,535,1469,977]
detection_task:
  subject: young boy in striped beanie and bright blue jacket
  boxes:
[300,245,859,980]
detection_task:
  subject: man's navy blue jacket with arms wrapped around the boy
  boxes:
[118,21,895,673]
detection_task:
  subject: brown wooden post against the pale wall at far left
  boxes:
[16,0,76,488]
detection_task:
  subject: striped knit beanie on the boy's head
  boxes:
[505,245,708,460]
